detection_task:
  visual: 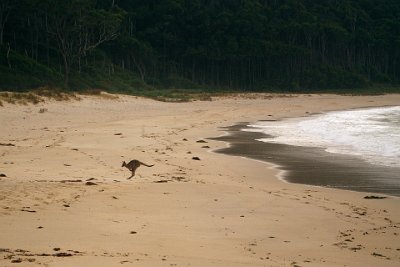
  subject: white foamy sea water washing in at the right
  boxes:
[247,106,400,168]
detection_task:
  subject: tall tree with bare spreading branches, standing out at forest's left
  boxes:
[44,0,124,86]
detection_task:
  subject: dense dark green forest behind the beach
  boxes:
[0,0,400,92]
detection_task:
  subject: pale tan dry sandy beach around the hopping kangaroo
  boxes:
[0,94,400,266]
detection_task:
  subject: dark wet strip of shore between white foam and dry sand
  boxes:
[214,123,400,196]
